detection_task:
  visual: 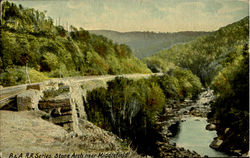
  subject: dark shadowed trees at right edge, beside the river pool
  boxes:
[212,44,249,152]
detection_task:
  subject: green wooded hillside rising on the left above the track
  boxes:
[0,2,151,85]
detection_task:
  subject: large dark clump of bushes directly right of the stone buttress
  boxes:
[86,77,165,155]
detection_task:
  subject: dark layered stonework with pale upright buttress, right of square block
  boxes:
[38,83,82,135]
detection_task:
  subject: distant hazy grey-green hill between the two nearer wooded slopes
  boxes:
[89,30,209,58]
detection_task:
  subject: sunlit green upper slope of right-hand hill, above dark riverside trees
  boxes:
[144,17,249,84]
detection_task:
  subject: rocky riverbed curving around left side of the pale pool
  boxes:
[154,89,214,157]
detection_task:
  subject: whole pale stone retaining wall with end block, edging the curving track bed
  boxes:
[1,74,154,134]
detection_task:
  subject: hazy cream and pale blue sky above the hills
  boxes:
[14,0,249,32]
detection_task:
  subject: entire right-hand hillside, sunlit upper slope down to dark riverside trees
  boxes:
[144,17,249,153]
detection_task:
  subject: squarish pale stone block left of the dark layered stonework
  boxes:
[17,89,41,111]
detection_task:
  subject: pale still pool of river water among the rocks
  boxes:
[171,117,228,157]
